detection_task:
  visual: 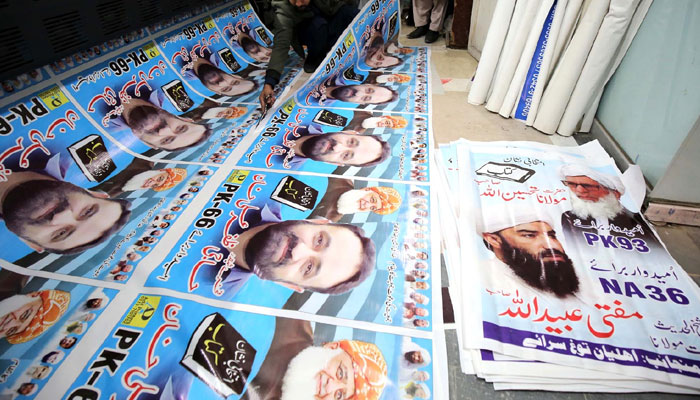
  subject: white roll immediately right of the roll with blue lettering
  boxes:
[532,0,610,135]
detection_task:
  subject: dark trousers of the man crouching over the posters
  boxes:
[297,3,359,65]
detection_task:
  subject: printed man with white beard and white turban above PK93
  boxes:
[559,164,659,251]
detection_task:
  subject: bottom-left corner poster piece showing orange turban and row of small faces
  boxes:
[0,269,117,399]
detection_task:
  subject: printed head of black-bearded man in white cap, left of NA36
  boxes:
[482,209,579,298]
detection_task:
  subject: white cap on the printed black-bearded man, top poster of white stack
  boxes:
[476,202,555,234]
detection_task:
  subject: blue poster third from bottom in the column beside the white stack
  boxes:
[238,99,430,182]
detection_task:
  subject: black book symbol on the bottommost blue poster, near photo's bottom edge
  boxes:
[180,313,256,398]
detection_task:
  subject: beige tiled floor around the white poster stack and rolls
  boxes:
[401,26,700,400]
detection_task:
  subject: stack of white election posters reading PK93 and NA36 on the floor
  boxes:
[436,140,700,394]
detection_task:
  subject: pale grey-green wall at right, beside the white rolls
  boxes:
[597,0,700,188]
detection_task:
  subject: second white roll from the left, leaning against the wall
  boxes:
[486,0,539,112]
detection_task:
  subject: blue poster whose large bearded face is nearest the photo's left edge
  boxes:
[0,86,215,282]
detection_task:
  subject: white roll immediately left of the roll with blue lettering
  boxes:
[498,0,554,118]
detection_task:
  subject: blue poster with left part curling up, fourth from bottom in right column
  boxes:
[295,32,429,113]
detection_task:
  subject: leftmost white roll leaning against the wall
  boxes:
[467,0,515,105]
